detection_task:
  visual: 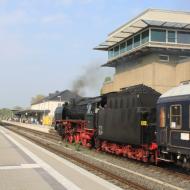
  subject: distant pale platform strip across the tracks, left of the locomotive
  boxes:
[3,120,52,133]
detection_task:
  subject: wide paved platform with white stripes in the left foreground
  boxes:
[0,126,121,190]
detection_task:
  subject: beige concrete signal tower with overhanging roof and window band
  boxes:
[94,9,190,94]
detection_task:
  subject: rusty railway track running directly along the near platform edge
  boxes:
[0,123,148,190]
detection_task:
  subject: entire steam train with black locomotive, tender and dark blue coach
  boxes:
[55,82,190,168]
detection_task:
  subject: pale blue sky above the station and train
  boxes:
[0,0,190,108]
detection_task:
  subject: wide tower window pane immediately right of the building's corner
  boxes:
[151,29,166,42]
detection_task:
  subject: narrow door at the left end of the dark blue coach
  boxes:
[159,105,168,145]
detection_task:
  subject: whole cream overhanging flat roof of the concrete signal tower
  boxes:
[94,9,190,51]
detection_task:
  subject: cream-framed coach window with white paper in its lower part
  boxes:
[170,105,182,129]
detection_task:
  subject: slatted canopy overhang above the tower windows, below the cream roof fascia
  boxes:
[94,19,190,51]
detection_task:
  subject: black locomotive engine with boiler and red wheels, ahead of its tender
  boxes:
[54,97,106,147]
